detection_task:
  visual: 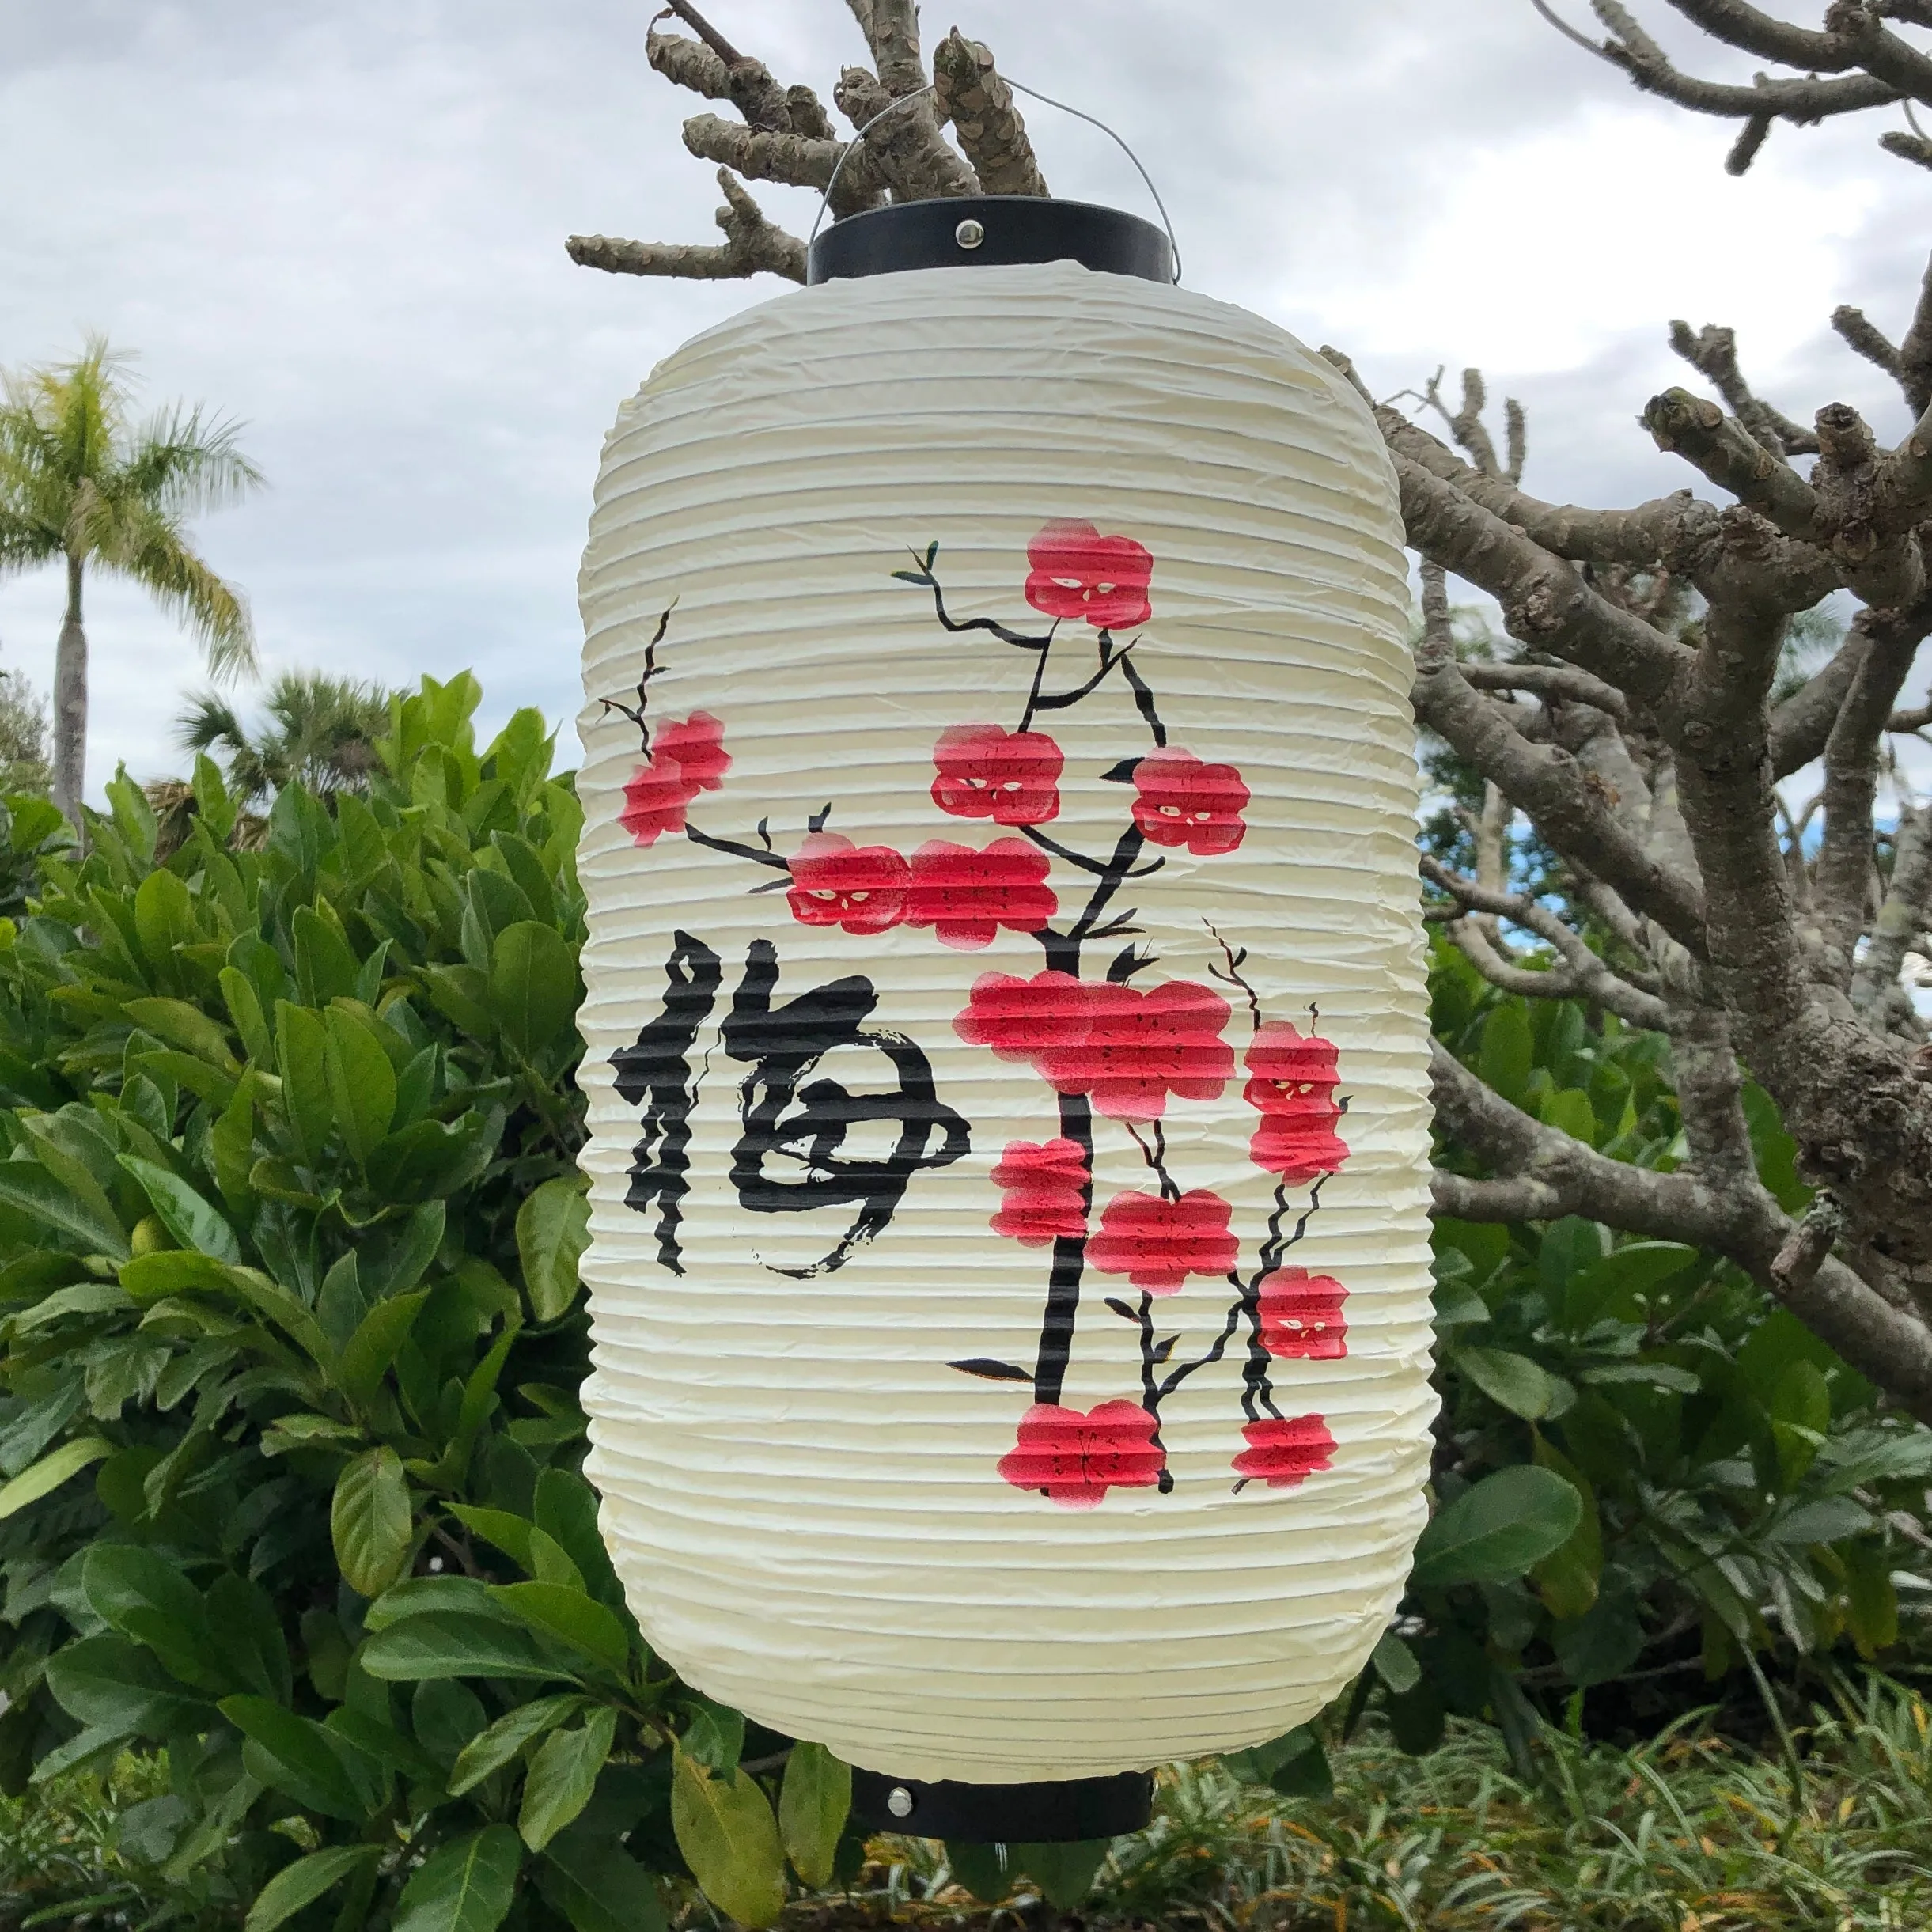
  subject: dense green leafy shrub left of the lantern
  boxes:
[0,678,843,1932]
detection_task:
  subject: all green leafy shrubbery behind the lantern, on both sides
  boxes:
[0,678,1932,1932]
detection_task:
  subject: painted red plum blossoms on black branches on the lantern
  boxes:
[612,520,1349,1509]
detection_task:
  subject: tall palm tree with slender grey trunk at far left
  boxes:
[0,336,261,827]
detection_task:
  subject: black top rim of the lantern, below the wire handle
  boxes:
[805,195,1175,284]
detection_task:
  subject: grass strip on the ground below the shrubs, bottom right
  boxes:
[854,1677,1932,1932]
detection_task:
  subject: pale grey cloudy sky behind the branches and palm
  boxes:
[0,0,1932,794]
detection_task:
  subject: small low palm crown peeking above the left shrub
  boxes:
[174,670,392,805]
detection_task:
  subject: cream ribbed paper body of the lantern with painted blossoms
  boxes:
[581,263,1435,1782]
